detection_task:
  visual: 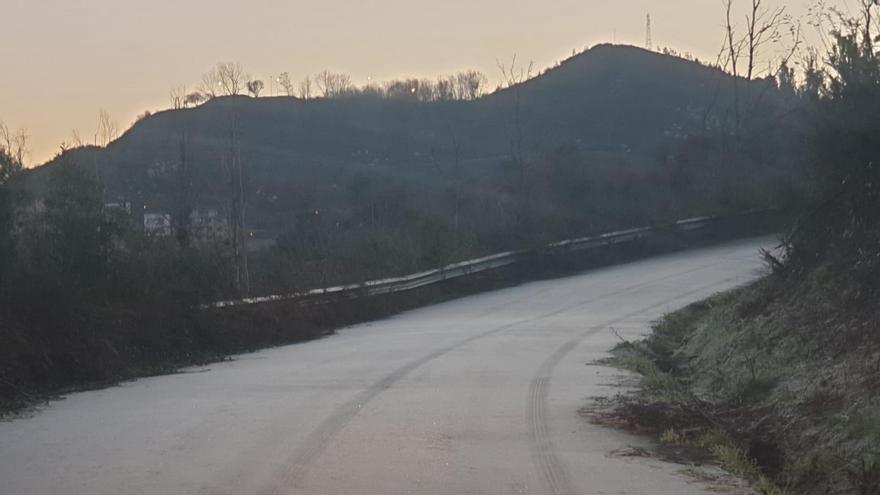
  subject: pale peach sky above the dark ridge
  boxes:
[0,0,853,165]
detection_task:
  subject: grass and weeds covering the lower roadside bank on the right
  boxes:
[606,281,880,495]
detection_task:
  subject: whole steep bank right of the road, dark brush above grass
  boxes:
[617,192,880,495]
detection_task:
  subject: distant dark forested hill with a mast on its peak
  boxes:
[20,45,796,247]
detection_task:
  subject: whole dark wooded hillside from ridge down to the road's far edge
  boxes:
[0,46,799,418]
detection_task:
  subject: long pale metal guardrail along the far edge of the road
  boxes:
[201,210,773,309]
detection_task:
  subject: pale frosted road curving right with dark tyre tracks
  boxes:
[0,239,770,495]
